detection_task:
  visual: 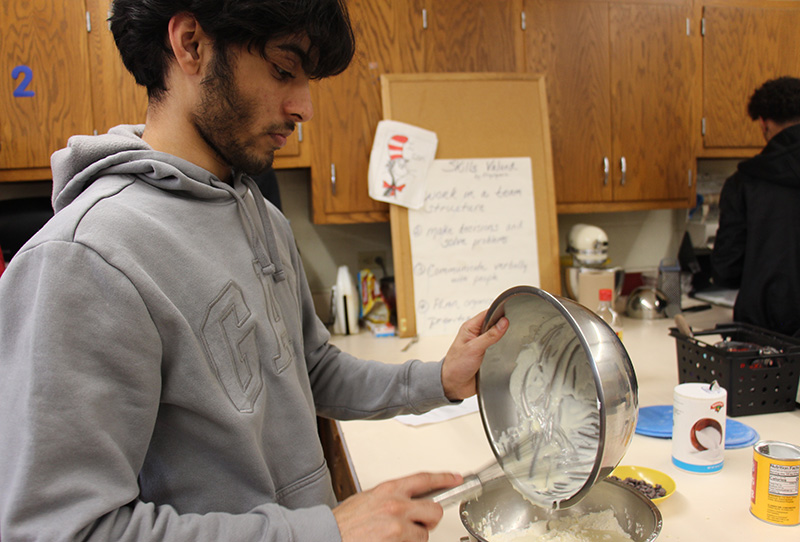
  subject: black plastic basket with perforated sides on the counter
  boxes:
[669,323,800,417]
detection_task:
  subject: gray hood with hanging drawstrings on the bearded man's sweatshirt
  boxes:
[50,124,284,281]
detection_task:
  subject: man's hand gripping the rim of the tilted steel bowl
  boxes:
[442,311,508,401]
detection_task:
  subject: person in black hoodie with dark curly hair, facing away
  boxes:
[712,77,800,336]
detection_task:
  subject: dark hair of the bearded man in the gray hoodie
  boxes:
[109,0,355,101]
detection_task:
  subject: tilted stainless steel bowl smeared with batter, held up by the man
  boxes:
[478,286,638,508]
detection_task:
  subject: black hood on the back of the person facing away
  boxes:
[738,124,800,189]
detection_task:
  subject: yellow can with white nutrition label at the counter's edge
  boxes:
[750,440,800,525]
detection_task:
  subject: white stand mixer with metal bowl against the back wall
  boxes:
[563,224,625,310]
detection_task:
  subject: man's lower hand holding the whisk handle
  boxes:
[333,473,463,542]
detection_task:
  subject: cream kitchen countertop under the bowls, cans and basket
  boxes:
[332,307,800,542]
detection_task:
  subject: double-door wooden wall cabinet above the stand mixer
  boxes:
[525,0,697,212]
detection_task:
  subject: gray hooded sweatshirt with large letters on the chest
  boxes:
[0,126,447,542]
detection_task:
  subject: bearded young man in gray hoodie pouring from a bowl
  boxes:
[0,0,507,542]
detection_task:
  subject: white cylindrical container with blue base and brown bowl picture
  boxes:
[672,380,728,474]
